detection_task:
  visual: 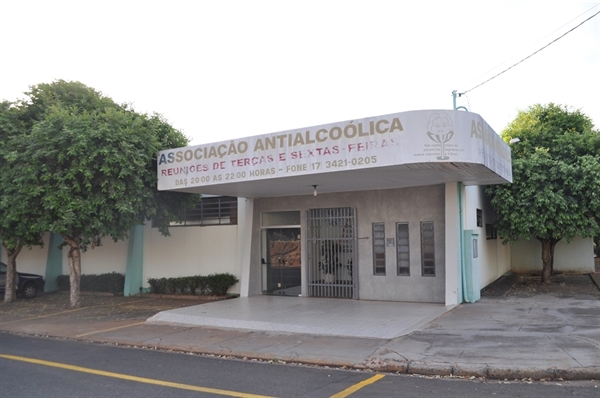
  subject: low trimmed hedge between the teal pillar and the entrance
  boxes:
[148,273,239,296]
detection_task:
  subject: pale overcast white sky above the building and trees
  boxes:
[0,0,600,145]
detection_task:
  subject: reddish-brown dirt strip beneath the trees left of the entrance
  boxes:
[0,292,230,322]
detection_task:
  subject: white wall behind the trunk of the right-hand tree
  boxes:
[510,238,594,273]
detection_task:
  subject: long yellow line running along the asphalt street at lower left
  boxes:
[0,354,272,398]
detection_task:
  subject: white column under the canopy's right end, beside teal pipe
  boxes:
[445,182,462,305]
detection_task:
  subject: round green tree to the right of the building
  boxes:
[486,103,600,282]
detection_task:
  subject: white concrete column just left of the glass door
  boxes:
[238,198,254,297]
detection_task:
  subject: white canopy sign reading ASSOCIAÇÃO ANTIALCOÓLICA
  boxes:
[158,110,512,190]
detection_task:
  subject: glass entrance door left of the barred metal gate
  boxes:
[261,228,302,296]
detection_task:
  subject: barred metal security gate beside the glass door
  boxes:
[306,207,358,298]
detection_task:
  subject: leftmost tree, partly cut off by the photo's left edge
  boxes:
[0,101,44,303]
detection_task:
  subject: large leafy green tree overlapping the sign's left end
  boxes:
[3,80,196,307]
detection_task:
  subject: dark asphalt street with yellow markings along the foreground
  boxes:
[0,333,599,398]
